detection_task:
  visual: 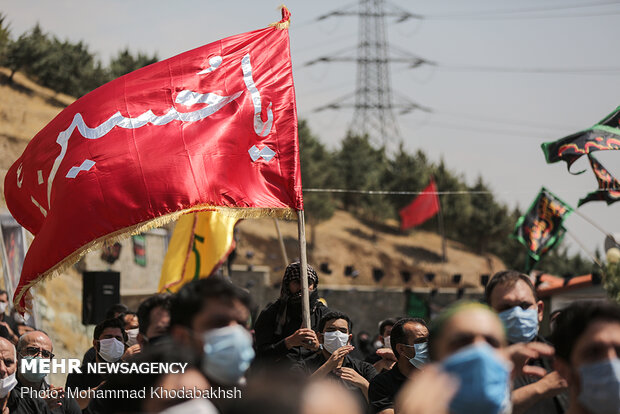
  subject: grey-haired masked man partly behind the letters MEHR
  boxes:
[17,331,81,414]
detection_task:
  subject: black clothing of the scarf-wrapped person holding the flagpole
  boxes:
[254,299,329,364]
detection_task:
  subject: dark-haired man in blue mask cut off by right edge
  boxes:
[549,301,620,414]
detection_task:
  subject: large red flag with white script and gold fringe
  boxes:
[4,9,303,309]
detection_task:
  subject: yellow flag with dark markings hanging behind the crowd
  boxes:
[159,211,238,292]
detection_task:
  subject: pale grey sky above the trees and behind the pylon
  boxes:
[0,0,620,262]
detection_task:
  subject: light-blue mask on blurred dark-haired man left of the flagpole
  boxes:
[203,325,254,385]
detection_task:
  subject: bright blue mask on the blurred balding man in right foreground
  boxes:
[442,343,511,414]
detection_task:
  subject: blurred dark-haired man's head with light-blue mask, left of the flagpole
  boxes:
[170,276,254,394]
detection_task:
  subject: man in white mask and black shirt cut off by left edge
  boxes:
[0,338,50,414]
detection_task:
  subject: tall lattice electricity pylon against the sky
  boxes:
[306,0,430,146]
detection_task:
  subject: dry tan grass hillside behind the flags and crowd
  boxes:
[0,68,503,385]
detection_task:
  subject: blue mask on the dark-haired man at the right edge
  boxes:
[578,358,620,414]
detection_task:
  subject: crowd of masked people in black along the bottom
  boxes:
[0,263,620,414]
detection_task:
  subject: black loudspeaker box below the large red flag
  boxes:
[82,272,121,325]
